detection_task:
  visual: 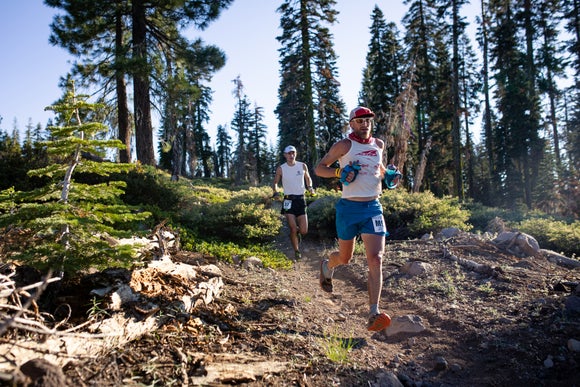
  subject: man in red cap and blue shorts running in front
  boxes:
[314,106,402,331]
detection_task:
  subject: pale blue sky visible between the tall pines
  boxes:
[0,0,477,149]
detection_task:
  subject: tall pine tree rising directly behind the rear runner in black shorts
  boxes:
[276,0,344,167]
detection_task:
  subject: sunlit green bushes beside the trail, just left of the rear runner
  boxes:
[150,182,292,269]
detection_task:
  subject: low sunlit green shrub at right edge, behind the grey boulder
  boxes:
[510,218,580,257]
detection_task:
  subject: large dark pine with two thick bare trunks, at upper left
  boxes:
[45,0,232,165]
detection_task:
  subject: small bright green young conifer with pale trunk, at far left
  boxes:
[0,84,150,274]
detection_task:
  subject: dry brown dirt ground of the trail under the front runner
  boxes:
[1,229,580,386]
